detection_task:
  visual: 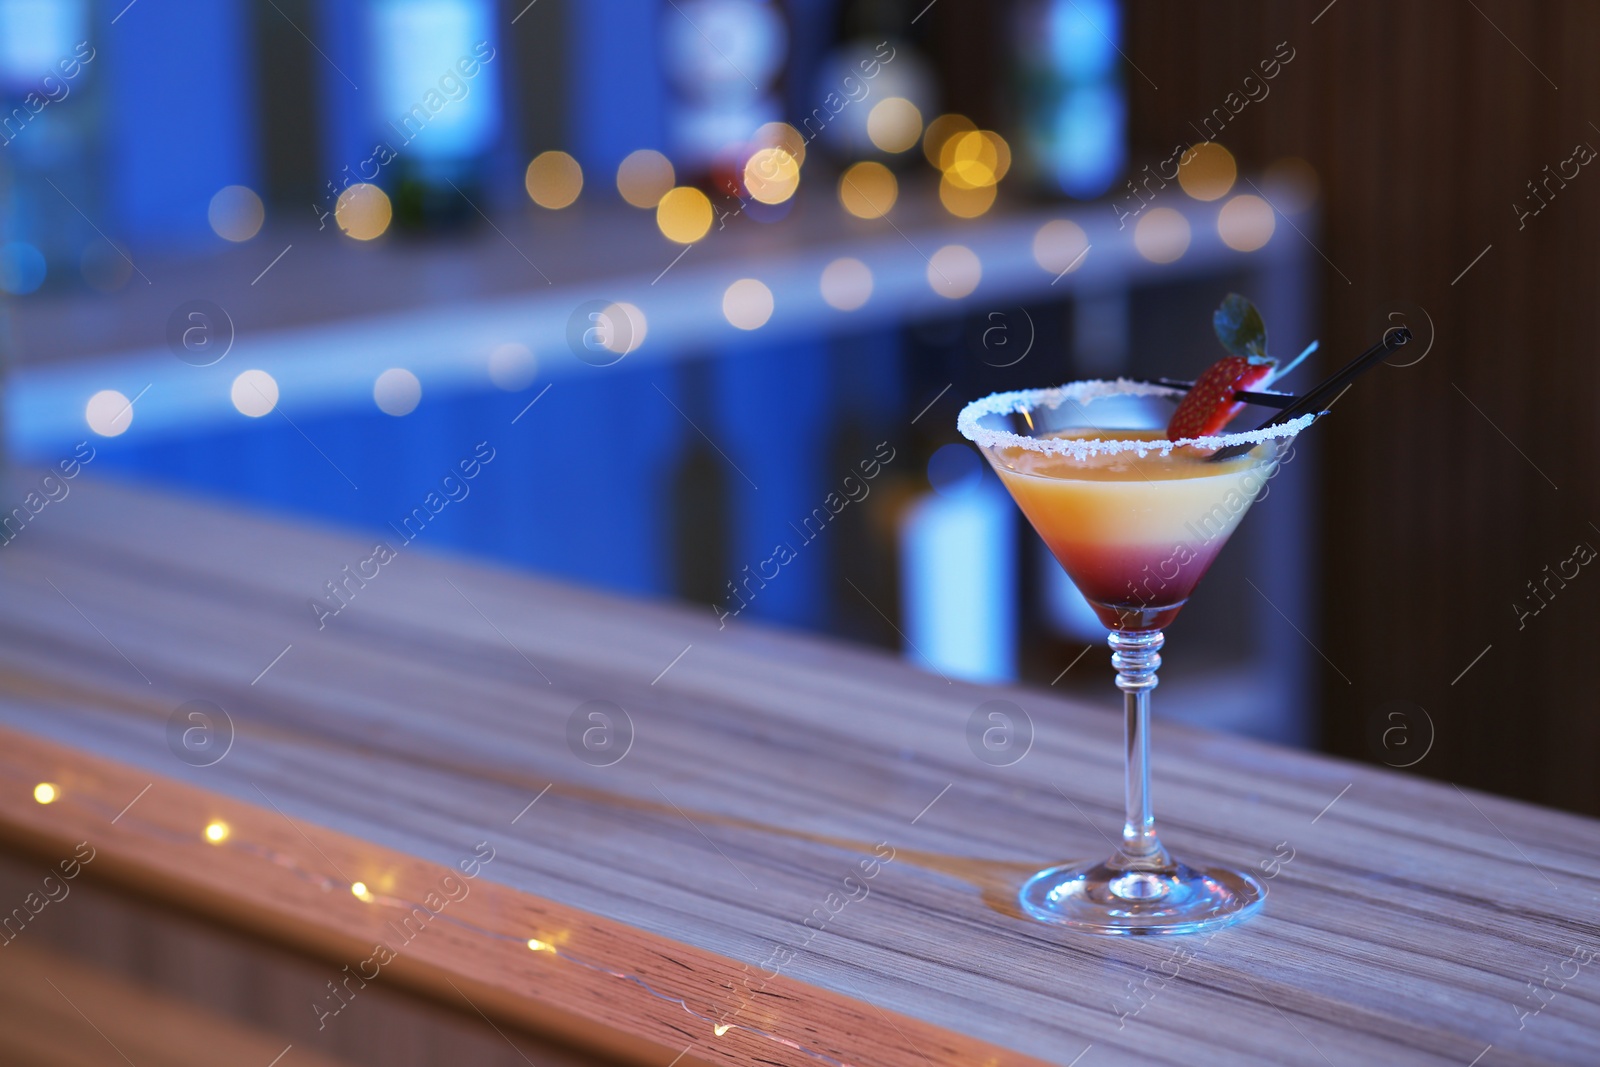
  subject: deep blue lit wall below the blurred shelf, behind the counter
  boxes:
[94,331,909,639]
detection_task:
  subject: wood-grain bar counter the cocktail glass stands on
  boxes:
[0,477,1600,1067]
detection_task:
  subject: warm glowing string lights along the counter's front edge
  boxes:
[21,782,851,1067]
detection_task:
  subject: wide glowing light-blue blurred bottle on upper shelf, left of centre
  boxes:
[368,0,502,229]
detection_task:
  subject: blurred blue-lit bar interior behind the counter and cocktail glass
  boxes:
[0,0,1600,813]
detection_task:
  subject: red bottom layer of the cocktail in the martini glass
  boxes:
[1045,537,1227,632]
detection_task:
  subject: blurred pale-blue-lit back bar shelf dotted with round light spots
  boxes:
[6,182,1315,458]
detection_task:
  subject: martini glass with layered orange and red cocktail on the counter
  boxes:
[957,379,1315,934]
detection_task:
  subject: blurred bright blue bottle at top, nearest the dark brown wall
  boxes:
[1014,0,1128,200]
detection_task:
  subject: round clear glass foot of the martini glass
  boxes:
[1019,862,1267,934]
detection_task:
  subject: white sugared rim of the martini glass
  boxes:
[955,378,1320,459]
